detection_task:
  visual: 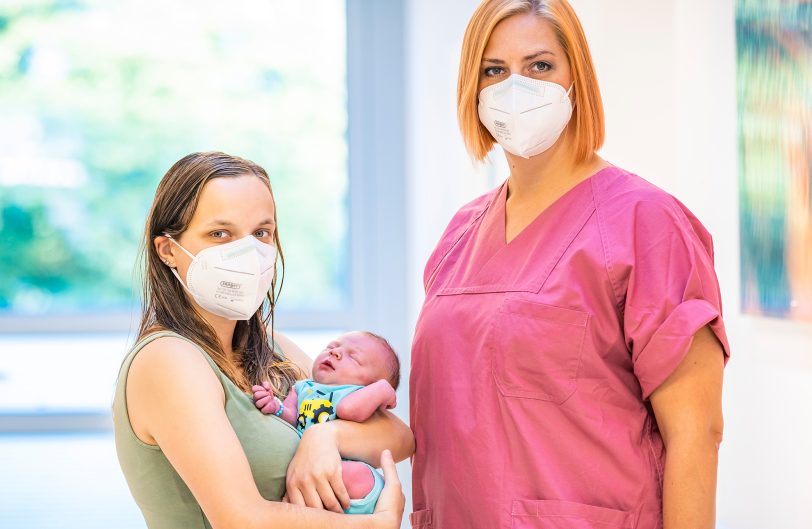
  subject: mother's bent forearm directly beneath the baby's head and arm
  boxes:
[334,411,414,467]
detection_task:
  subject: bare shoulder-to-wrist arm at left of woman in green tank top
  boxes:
[127,338,402,529]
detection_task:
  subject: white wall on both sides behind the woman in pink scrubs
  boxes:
[407,0,812,529]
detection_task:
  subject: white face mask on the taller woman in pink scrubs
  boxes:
[479,74,572,158]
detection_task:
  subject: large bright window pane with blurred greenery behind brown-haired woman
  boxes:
[0,0,348,317]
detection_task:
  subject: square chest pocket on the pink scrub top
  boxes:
[489,298,589,404]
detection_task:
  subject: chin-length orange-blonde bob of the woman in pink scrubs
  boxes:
[457,0,604,163]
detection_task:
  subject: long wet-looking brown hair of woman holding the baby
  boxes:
[138,152,303,396]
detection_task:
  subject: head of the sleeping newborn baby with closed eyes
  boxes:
[313,331,400,389]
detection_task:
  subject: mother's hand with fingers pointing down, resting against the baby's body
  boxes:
[286,423,348,512]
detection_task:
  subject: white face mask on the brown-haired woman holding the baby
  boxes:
[165,234,277,320]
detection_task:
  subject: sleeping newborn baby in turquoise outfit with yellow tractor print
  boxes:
[253,331,400,514]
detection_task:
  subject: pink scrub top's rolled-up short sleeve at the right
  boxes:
[623,201,730,399]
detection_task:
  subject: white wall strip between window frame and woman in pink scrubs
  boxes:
[406,0,488,319]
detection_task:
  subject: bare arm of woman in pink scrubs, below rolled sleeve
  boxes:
[651,327,724,529]
